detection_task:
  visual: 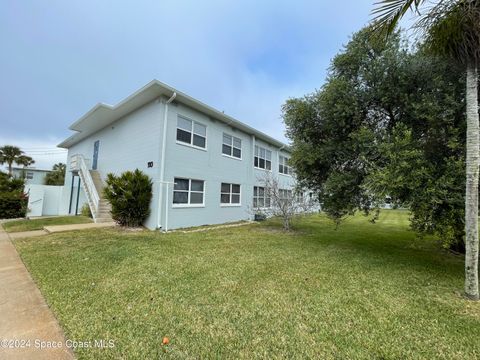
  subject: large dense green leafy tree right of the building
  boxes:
[283,28,466,292]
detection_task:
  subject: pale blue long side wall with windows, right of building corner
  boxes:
[162,104,293,228]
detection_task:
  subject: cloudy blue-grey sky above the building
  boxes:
[0,0,373,167]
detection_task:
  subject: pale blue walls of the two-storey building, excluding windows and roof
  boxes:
[63,99,293,229]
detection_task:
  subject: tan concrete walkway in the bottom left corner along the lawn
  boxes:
[0,225,74,360]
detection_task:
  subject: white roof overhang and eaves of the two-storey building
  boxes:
[58,80,288,151]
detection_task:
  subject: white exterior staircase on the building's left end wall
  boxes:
[70,154,113,223]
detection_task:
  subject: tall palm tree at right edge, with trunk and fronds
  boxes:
[373,0,480,300]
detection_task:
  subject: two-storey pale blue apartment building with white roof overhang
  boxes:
[58,80,294,229]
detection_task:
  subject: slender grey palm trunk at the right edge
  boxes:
[465,63,480,300]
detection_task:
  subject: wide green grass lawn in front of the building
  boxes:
[15,211,480,359]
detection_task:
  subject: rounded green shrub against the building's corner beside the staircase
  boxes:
[104,169,152,226]
